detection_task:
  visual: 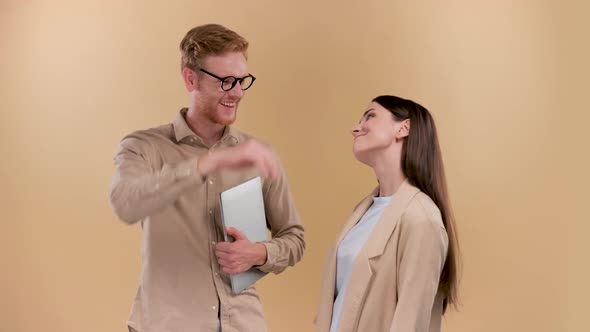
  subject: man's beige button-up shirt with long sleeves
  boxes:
[110,109,305,332]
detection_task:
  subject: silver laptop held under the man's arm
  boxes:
[219,177,267,294]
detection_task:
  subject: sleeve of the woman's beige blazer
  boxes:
[390,214,448,332]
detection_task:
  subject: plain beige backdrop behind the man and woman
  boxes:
[0,0,590,332]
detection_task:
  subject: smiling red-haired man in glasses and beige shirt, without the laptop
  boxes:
[110,24,305,332]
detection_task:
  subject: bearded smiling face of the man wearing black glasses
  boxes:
[194,52,248,126]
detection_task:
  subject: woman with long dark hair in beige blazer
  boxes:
[316,96,458,332]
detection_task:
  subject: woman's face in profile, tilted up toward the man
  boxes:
[352,102,403,163]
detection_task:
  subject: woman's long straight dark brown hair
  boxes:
[373,96,459,313]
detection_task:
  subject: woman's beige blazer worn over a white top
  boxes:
[315,181,448,332]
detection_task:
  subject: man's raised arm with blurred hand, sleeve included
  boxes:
[110,134,277,224]
